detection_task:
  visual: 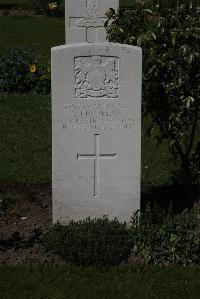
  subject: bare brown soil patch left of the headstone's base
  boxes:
[0,184,64,265]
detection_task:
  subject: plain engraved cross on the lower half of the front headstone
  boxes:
[77,134,116,197]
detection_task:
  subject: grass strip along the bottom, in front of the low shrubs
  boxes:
[0,266,200,299]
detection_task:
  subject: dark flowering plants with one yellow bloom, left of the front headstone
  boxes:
[0,47,51,94]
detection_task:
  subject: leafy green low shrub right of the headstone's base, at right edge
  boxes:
[131,209,200,266]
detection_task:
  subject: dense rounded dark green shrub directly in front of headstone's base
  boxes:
[46,217,133,266]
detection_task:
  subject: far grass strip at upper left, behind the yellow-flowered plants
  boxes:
[0,16,65,60]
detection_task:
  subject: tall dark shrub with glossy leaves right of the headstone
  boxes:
[105,0,200,193]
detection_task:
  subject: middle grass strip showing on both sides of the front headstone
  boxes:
[0,95,173,185]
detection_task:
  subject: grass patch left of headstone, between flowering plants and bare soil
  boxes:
[0,95,51,182]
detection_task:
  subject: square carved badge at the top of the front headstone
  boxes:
[74,56,119,99]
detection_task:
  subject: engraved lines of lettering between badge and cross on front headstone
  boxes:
[61,103,134,131]
